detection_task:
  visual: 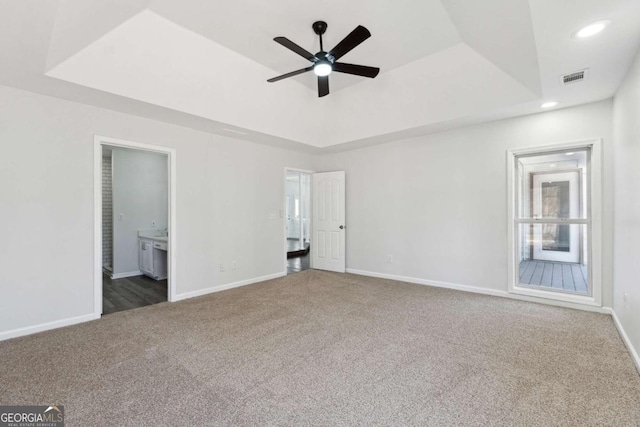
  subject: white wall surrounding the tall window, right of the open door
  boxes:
[316,100,612,306]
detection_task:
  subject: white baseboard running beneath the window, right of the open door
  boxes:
[347,268,613,314]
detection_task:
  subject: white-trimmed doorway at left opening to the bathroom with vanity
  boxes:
[94,136,175,316]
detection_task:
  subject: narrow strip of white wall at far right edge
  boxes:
[613,47,640,369]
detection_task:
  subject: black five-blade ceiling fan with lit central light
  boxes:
[267,21,380,97]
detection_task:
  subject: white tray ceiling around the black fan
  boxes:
[0,0,640,151]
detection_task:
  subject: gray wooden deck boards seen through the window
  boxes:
[520,260,589,294]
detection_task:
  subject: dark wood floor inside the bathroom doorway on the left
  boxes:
[102,274,167,315]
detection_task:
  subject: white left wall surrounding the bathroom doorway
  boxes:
[0,87,312,339]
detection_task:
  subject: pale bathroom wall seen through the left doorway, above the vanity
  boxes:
[112,148,169,274]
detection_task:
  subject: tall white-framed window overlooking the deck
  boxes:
[510,143,599,303]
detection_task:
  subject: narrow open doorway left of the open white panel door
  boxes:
[284,169,311,274]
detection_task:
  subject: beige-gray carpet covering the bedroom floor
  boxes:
[0,270,640,426]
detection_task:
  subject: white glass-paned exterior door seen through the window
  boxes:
[533,172,580,263]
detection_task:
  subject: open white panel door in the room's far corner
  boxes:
[311,171,346,273]
